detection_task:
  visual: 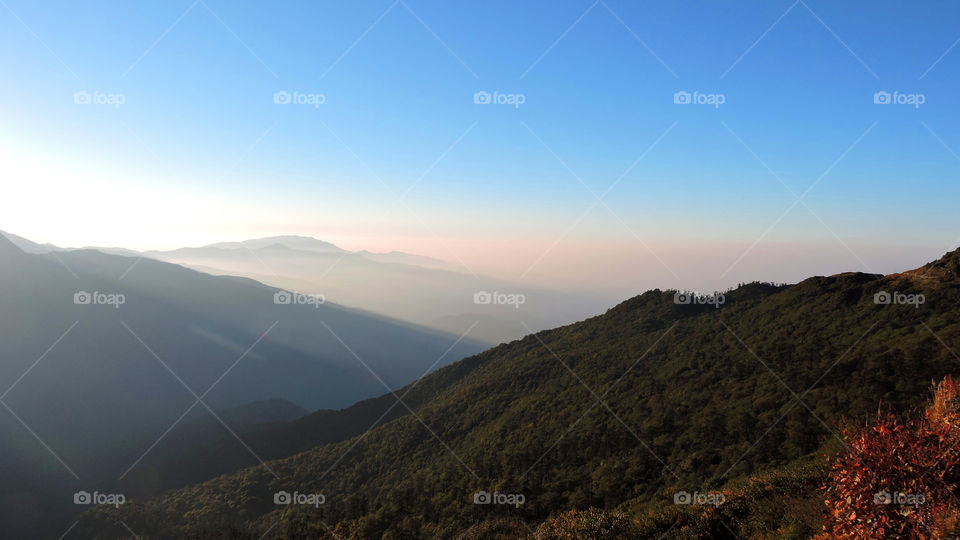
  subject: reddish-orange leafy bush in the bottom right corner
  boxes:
[824,377,960,539]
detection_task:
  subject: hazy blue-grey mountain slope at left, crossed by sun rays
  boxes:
[0,231,483,534]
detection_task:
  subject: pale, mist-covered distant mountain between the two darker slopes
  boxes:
[144,236,610,344]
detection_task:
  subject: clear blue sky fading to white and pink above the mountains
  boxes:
[0,0,960,297]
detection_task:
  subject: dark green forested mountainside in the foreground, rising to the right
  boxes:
[76,251,960,538]
